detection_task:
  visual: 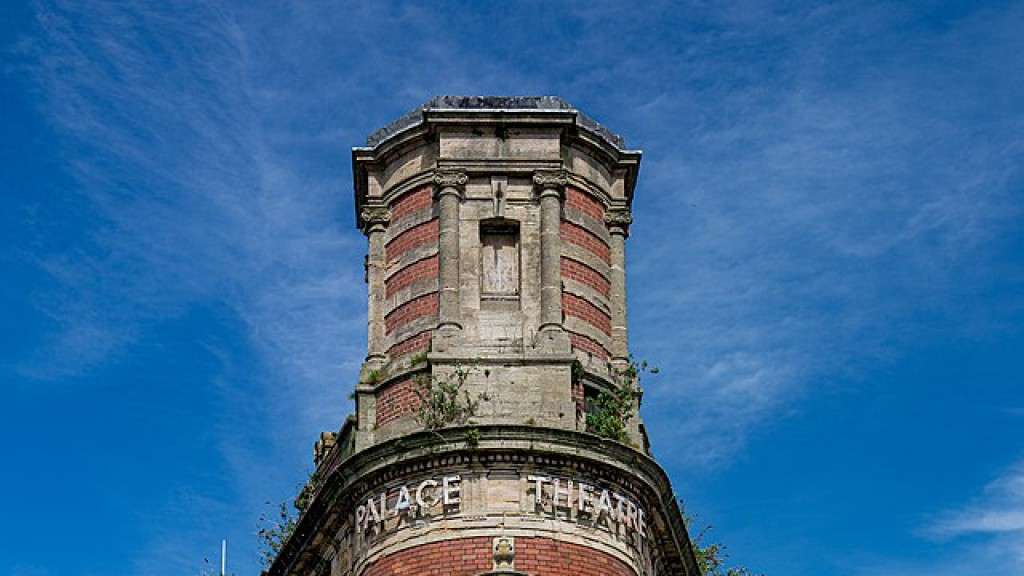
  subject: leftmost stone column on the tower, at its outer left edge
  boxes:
[360,205,391,369]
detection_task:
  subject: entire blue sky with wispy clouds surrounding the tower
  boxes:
[0,1,1024,576]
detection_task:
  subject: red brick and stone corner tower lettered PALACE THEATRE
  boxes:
[269,96,697,576]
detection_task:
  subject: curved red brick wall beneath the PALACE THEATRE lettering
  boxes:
[364,537,637,576]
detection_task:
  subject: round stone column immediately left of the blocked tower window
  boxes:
[433,171,469,352]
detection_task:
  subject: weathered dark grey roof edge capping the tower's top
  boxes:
[367,96,626,152]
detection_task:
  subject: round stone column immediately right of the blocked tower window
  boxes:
[534,170,569,353]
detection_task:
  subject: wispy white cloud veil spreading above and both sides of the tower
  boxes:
[12,2,1024,572]
